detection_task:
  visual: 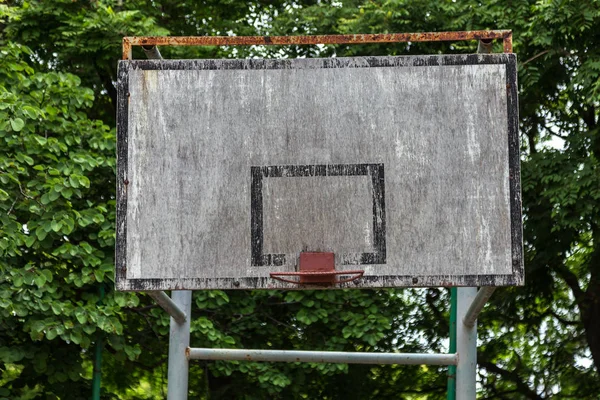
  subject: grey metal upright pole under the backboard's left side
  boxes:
[167,290,192,400]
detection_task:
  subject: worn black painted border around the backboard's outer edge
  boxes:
[115,54,525,291]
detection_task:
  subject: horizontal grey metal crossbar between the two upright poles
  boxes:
[186,348,458,365]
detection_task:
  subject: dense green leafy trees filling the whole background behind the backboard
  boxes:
[0,0,600,399]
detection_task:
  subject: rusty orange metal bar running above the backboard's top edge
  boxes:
[123,30,512,60]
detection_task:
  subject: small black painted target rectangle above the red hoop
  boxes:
[250,164,386,267]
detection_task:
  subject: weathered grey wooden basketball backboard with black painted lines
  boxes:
[116,54,524,290]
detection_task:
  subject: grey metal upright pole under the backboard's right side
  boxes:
[456,288,477,400]
